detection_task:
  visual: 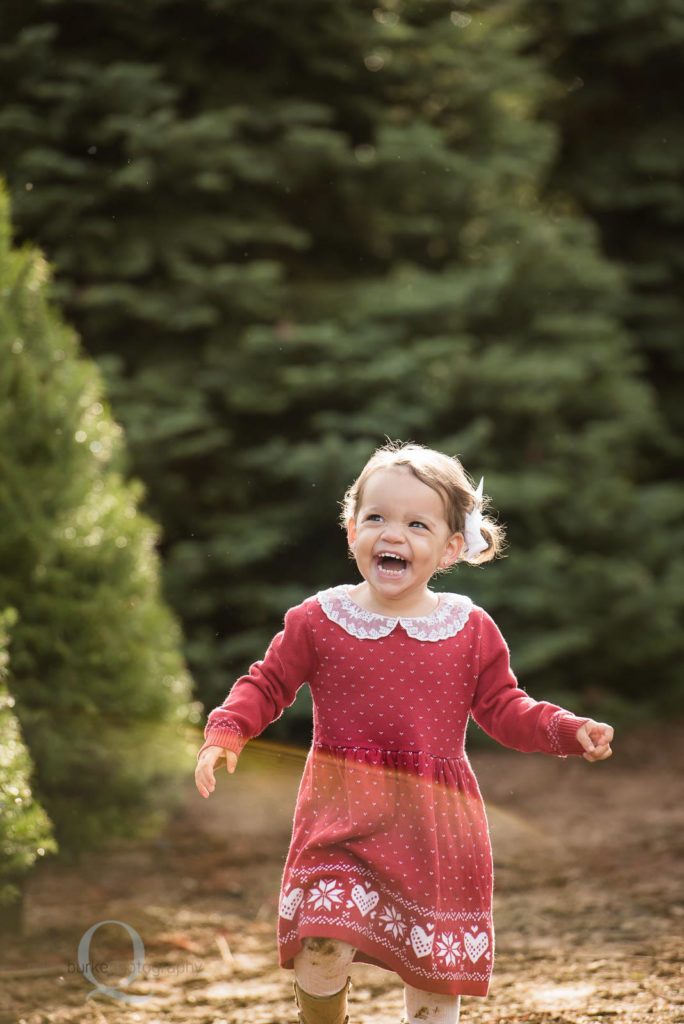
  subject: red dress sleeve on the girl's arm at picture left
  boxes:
[198,604,316,758]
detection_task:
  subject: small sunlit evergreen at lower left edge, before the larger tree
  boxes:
[0,609,56,935]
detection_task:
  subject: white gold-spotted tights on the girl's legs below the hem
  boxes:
[295,938,461,1024]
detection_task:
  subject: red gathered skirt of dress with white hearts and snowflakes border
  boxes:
[277,741,495,995]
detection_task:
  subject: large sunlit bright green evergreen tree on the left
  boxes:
[0,184,197,855]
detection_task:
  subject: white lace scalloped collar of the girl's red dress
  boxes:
[316,584,473,641]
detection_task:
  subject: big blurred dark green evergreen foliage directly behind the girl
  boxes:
[0,0,684,741]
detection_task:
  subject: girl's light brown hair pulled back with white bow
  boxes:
[340,440,505,565]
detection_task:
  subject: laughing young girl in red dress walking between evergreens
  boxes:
[196,443,613,1024]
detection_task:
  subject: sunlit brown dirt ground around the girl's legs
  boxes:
[0,724,684,1024]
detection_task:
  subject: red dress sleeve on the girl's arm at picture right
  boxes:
[470,611,589,758]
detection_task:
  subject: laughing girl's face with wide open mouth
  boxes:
[347,466,465,614]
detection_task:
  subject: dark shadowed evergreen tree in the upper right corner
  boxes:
[521,0,684,466]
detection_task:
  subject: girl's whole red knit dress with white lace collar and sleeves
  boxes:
[198,586,587,995]
